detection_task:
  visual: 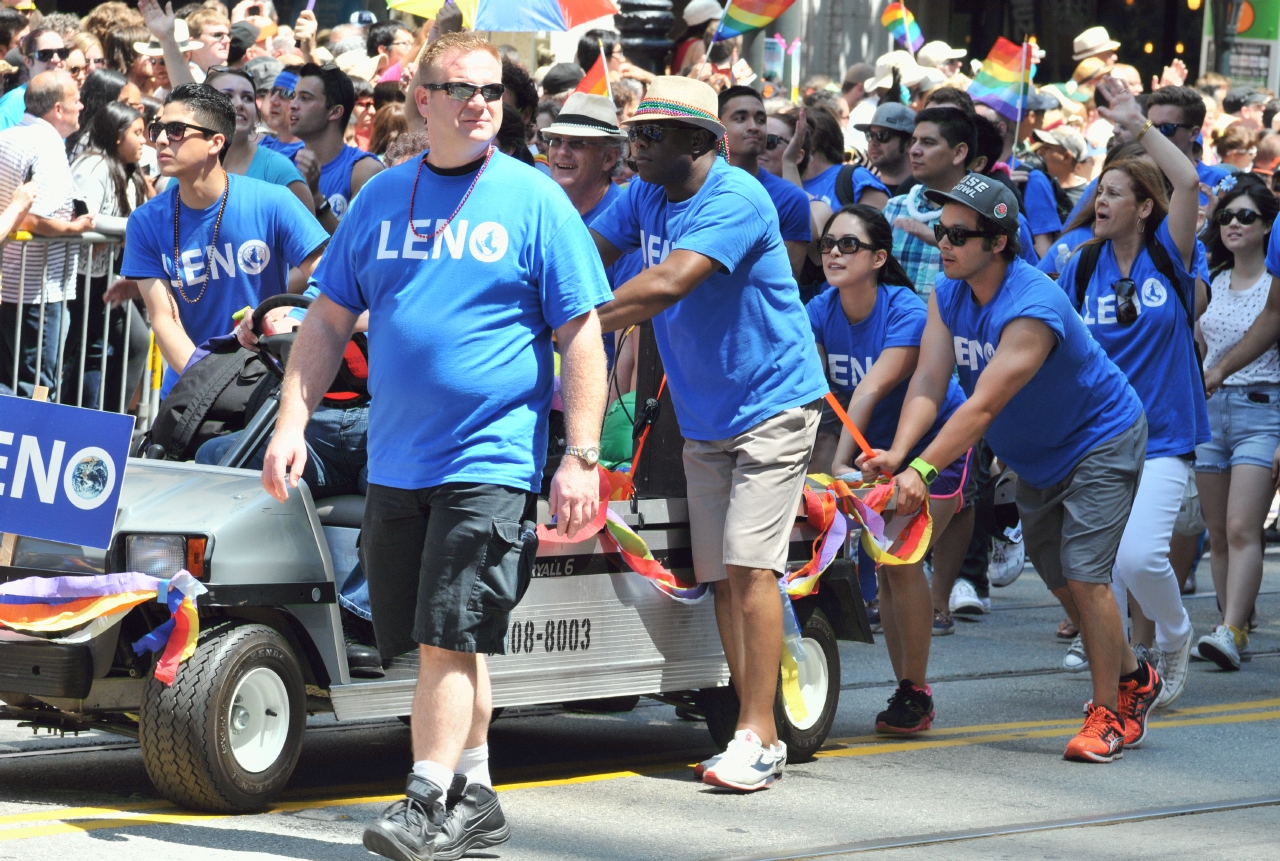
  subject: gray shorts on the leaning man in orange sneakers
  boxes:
[1016,416,1147,588]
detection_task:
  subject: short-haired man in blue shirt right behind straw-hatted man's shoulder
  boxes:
[719,87,808,279]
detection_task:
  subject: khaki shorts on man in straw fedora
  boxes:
[685,400,822,583]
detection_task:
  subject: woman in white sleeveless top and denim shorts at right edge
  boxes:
[1196,174,1280,670]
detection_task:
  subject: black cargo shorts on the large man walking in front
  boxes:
[360,482,538,661]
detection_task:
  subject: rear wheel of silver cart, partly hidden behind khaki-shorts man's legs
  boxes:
[696,609,840,762]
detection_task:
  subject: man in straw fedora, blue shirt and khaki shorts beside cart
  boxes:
[591,77,827,791]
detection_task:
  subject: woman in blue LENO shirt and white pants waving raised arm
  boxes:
[1059,77,1210,716]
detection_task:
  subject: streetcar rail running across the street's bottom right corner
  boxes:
[707,796,1280,861]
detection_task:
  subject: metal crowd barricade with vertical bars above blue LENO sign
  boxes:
[0,230,164,431]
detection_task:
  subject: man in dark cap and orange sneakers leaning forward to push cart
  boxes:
[867,174,1147,762]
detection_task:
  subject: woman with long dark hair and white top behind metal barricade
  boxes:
[63,101,155,412]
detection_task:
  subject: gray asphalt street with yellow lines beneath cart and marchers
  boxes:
[0,549,1280,861]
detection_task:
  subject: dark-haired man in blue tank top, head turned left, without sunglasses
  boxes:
[289,63,381,234]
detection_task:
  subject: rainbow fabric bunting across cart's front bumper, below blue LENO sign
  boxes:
[0,571,209,684]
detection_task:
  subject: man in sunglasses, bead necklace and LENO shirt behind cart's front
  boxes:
[119,83,329,394]
